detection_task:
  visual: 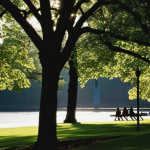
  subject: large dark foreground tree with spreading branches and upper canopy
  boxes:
[0,0,150,149]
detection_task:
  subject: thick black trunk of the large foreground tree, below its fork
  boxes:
[34,57,60,150]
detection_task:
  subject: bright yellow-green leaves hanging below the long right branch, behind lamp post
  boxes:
[77,33,150,101]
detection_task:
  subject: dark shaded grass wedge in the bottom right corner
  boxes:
[74,133,150,150]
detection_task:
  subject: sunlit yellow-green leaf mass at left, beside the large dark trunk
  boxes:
[0,22,35,92]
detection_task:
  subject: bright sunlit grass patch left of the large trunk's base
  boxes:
[0,127,38,150]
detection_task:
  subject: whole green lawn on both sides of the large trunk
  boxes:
[0,119,150,150]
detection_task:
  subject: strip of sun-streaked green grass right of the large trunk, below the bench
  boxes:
[57,122,150,139]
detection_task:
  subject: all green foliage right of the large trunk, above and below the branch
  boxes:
[75,1,150,101]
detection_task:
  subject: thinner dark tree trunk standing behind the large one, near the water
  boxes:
[64,57,78,123]
